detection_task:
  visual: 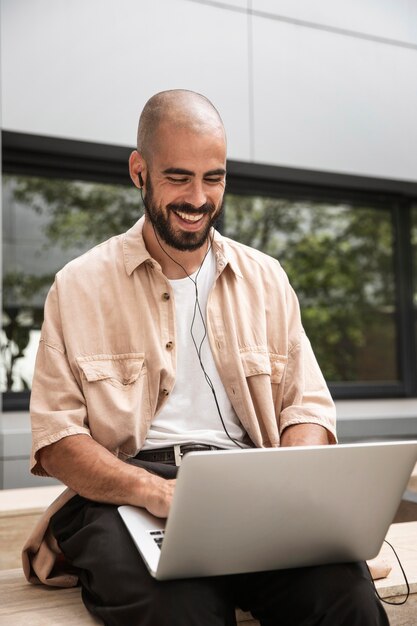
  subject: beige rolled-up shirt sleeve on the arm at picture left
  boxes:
[30,282,90,476]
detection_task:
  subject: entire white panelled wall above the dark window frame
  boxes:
[1,0,417,181]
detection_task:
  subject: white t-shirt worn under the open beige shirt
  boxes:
[143,245,246,450]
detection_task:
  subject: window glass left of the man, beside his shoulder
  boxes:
[0,175,141,392]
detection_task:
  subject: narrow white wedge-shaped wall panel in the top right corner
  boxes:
[252,0,417,44]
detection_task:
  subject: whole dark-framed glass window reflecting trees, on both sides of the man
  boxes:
[0,163,417,408]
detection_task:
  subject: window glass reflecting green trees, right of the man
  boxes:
[224,195,399,383]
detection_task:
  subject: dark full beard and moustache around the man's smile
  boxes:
[142,174,223,252]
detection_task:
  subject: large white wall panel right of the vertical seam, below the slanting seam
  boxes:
[253,18,417,180]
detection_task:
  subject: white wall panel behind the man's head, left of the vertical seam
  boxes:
[1,0,249,159]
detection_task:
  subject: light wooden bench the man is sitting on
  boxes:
[0,466,417,626]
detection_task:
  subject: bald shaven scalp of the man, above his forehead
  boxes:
[137,89,225,163]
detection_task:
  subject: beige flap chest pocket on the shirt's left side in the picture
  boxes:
[77,352,150,456]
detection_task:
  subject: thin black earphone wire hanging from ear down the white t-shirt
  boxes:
[138,172,243,448]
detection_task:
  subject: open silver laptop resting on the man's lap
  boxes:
[119,441,417,580]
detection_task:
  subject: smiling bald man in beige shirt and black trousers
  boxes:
[26,90,388,626]
